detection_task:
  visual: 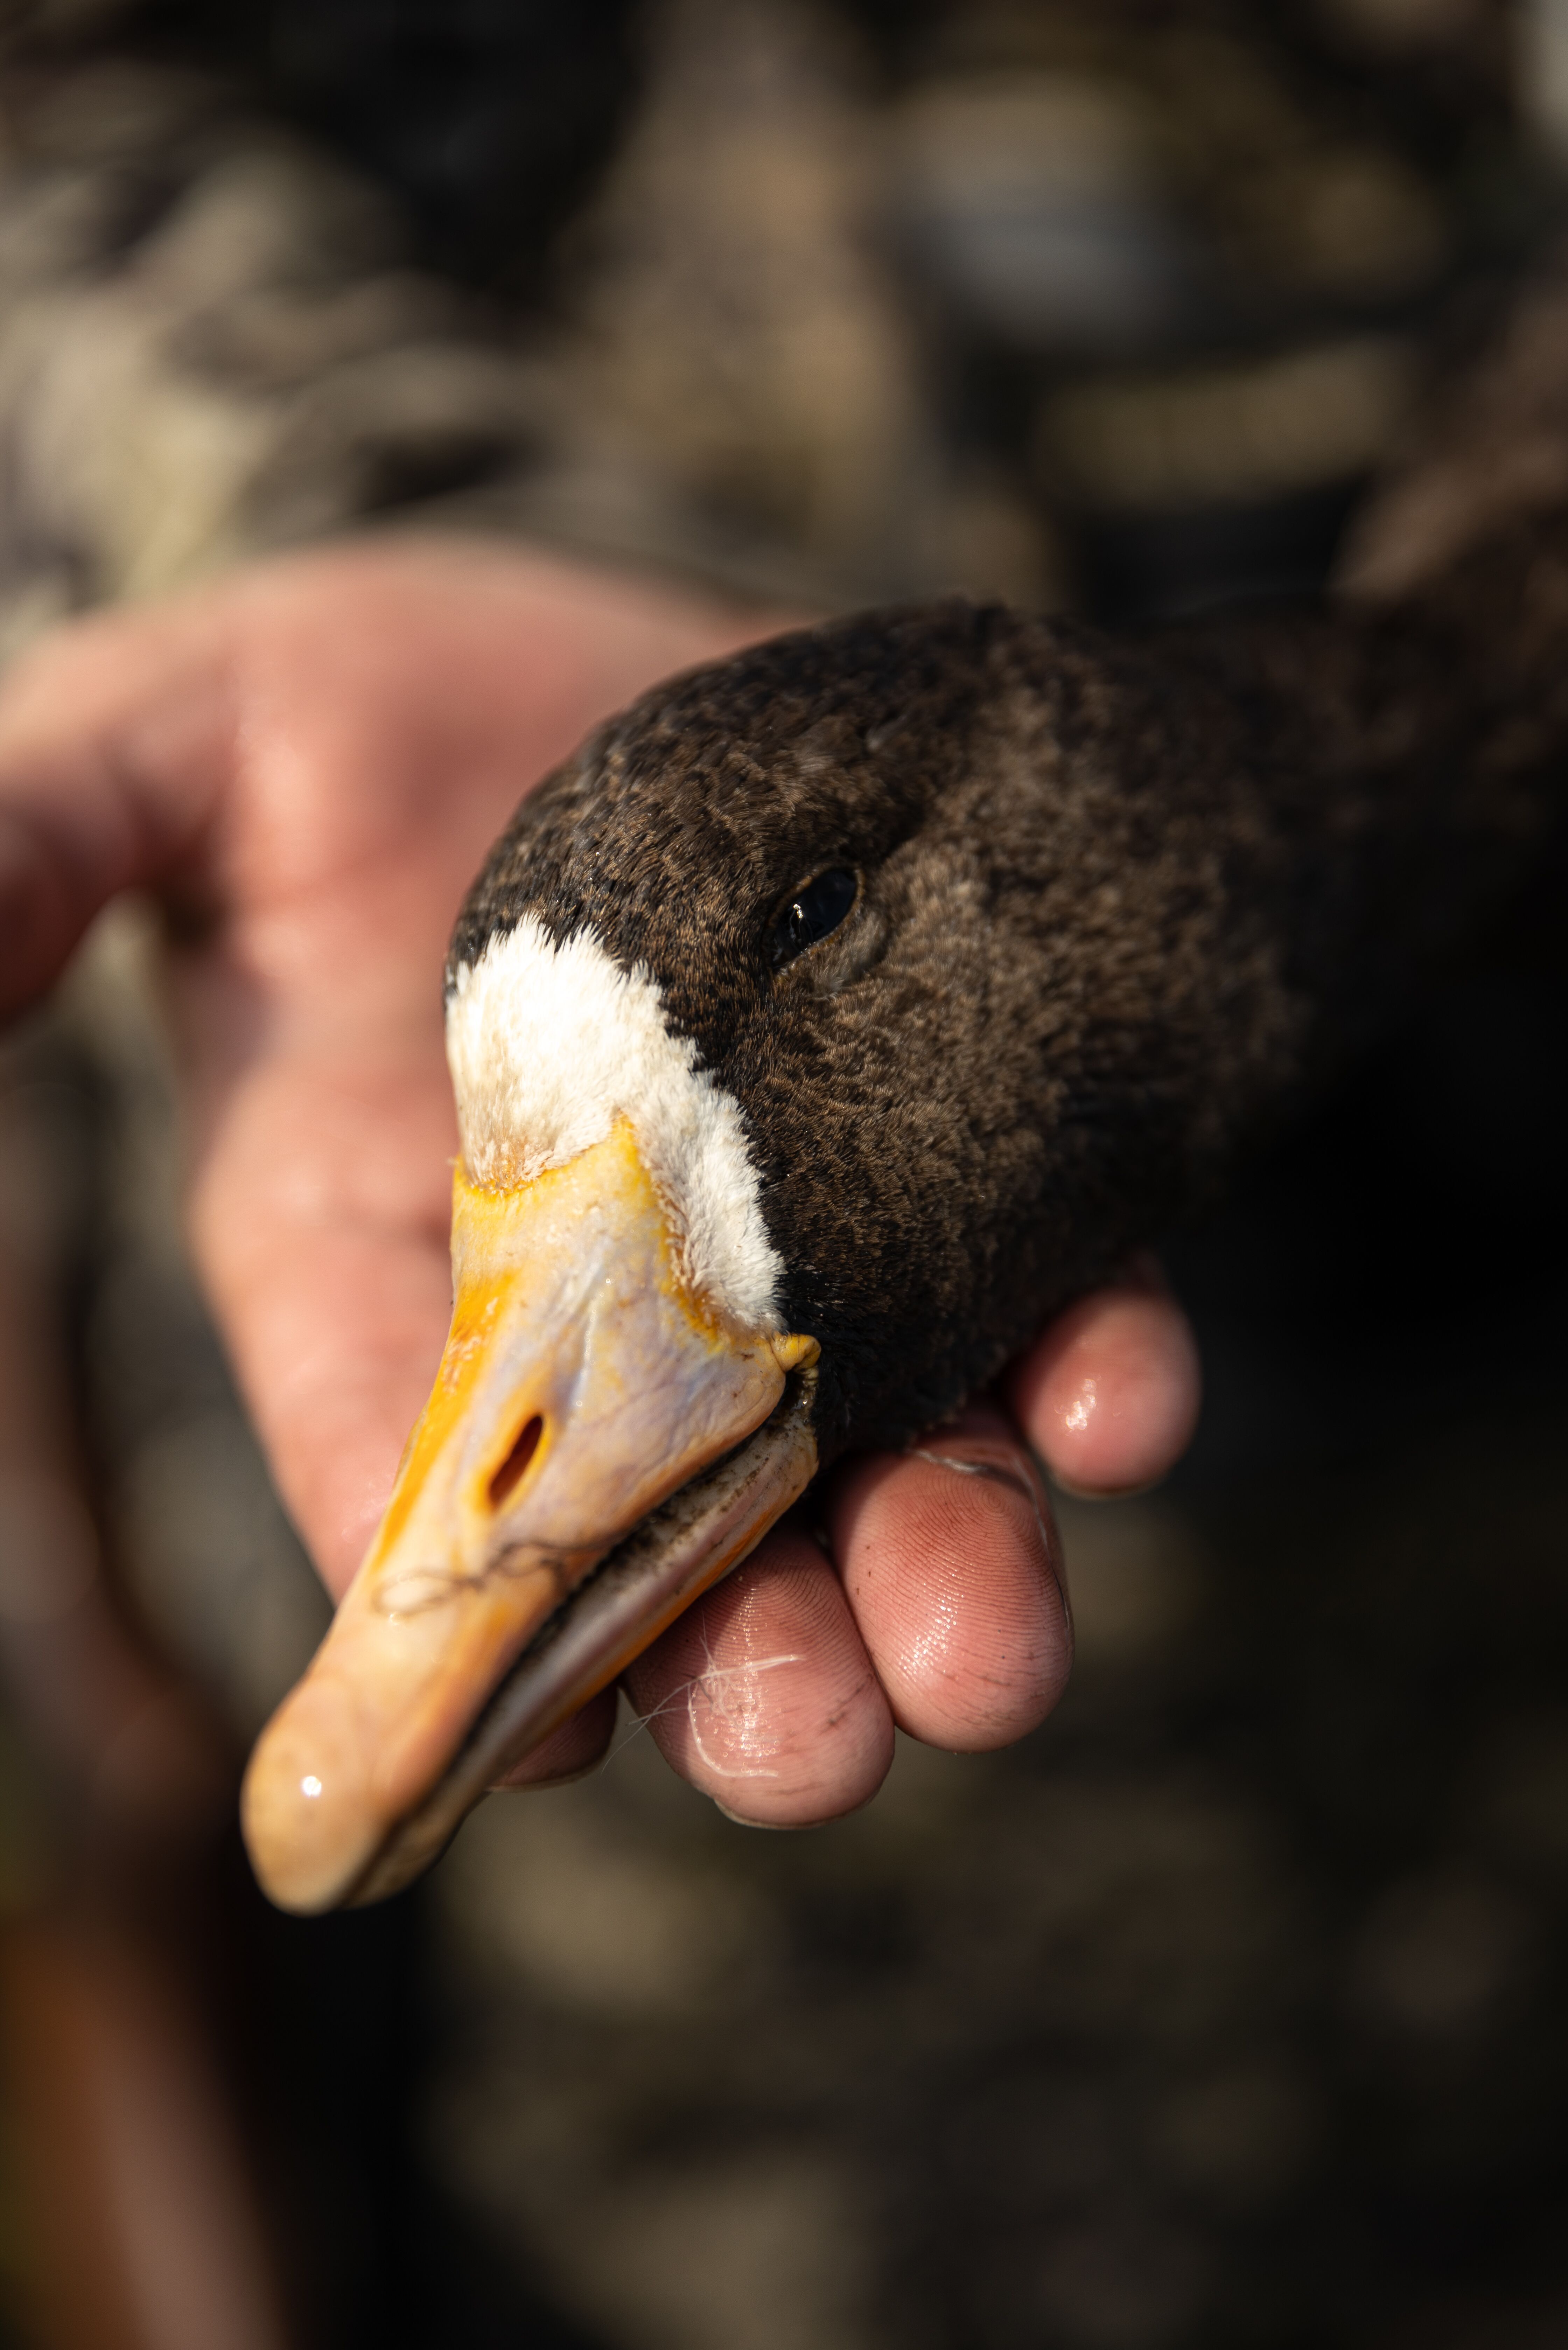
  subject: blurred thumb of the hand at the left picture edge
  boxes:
[0,602,235,1018]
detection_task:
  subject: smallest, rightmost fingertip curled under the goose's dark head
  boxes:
[1001,1260,1201,1494]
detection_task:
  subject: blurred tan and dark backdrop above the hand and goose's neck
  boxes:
[0,0,1540,642]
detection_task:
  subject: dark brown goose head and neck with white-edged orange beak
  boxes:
[247,270,1568,1908]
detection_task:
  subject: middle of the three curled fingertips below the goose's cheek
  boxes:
[827,1405,1072,1753]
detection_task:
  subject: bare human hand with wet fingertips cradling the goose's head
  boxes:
[0,543,1197,1826]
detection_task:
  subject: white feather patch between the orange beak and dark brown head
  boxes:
[447,914,783,1330]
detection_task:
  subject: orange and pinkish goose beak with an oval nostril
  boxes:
[242,1123,818,1911]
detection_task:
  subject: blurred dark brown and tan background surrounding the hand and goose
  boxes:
[0,0,1568,2350]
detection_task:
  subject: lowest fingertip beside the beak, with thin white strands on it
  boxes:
[625,1518,893,1828]
